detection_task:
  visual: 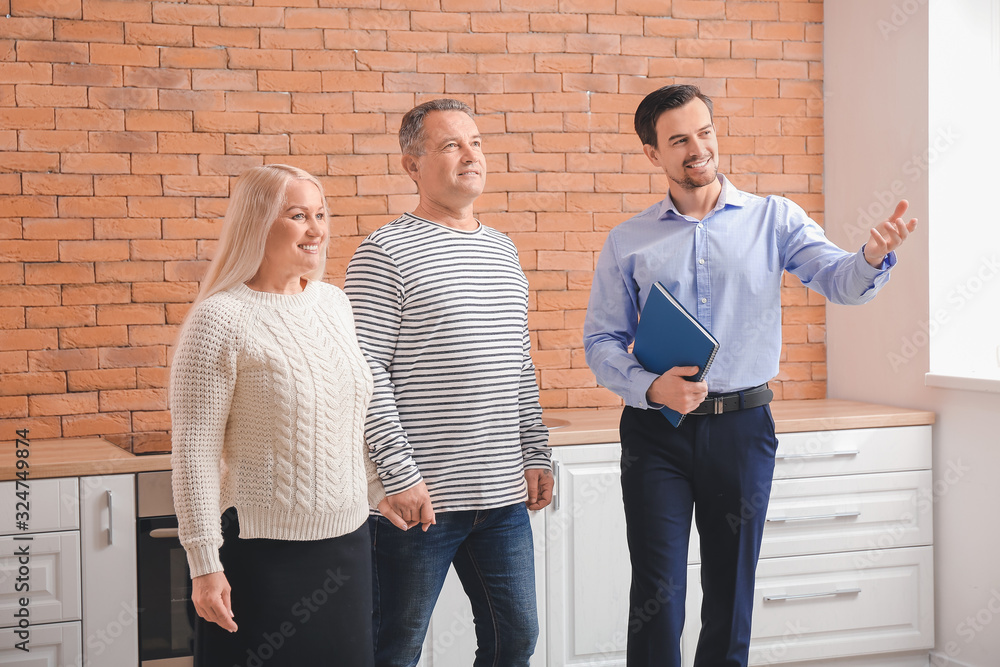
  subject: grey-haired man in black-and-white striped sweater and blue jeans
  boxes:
[345,99,553,667]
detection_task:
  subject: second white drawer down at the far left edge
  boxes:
[0,533,80,628]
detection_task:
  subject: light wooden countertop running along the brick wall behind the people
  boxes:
[0,399,934,480]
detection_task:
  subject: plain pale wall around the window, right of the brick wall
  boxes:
[824,0,1000,667]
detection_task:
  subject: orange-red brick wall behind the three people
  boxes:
[0,0,826,449]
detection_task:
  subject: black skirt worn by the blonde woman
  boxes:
[194,508,374,667]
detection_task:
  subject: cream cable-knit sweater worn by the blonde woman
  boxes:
[170,281,385,577]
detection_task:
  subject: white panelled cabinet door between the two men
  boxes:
[545,444,631,667]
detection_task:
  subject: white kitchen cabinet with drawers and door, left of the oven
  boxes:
[0,475,138,667]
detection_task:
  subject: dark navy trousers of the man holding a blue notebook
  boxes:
[621,405,778,667]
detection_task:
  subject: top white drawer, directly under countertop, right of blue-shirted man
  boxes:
[774,426,931,479]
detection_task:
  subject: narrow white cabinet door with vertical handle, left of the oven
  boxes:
[80,475,139,667]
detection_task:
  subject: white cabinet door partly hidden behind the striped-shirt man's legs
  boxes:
[418,511,545,667]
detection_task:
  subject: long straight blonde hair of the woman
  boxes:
[194,164,330,305]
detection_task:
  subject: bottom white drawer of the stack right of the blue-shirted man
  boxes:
[750,547,934,665]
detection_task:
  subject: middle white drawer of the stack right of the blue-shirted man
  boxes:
[760,470,933,566]
